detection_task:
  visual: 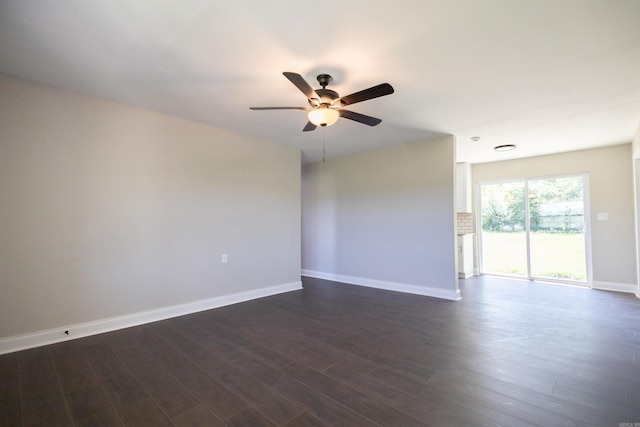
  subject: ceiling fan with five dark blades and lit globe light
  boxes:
[249,71,394,132]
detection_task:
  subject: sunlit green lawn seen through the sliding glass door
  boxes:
[482,231,586,281]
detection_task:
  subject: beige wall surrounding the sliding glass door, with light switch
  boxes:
[472,144,637,288]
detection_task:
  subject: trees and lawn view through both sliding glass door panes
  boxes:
[478,174,591,285]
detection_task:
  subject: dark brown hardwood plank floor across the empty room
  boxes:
[0,276,640,427]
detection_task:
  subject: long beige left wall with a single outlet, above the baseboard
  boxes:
[0,75,300,338]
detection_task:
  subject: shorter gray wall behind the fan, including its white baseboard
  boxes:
[302,136,458,299]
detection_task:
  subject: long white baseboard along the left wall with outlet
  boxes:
[0,281,302,354]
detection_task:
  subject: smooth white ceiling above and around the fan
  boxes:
[0,0,640,163]
